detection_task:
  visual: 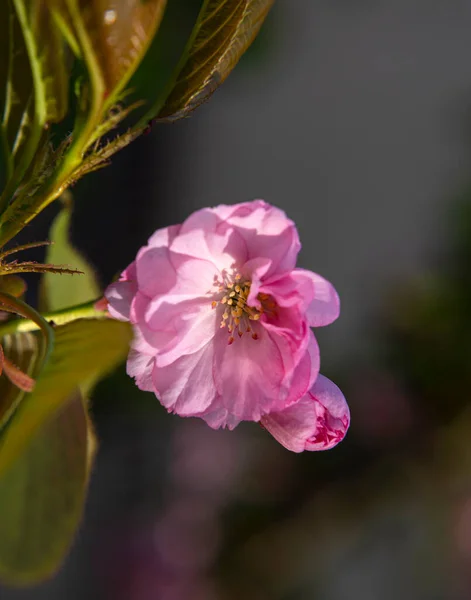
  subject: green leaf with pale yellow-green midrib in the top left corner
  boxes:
[0,0,68,209]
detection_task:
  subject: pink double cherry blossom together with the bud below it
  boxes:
[105,200,350,452]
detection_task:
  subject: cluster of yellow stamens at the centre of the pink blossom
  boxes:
[211,272,264,344]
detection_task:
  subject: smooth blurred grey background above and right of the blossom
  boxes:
[155,0,471,366]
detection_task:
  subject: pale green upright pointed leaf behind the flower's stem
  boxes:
[40,203,101,311]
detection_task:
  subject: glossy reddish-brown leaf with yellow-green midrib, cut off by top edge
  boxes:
[48,0,166,141]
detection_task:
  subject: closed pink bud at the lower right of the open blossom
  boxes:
[261,375,350,452]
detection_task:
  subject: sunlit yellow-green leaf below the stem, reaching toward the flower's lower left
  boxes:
[0,319,132,477]
